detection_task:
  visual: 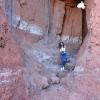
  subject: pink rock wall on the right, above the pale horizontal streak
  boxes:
[78,0,100,70]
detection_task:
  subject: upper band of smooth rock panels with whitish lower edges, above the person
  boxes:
[7,0,82,44]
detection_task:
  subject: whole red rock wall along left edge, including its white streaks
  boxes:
[0,2,27,100]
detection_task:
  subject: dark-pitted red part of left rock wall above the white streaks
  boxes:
[0,9,23,66]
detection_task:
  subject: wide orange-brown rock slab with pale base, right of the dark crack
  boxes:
[62,0,82,44]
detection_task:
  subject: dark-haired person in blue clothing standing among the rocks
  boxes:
[59,42,68,71]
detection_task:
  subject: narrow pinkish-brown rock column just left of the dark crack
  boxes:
[51,0,65,37]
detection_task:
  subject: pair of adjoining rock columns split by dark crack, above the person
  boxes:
[51,0,82,44]
